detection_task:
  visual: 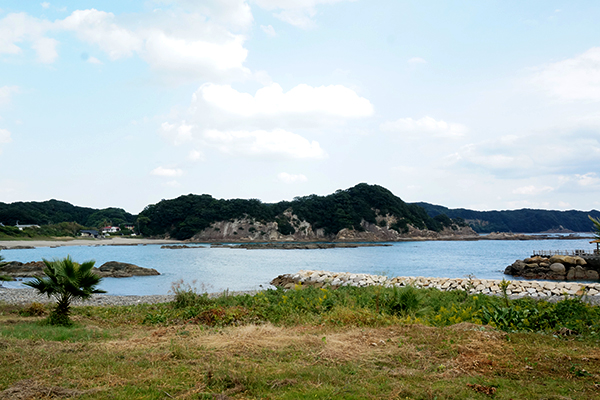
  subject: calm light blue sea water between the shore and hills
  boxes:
[2,239,593,295]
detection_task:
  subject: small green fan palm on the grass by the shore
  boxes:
[25,256,106,326]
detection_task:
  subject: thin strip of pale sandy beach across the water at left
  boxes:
[0,237,184,250]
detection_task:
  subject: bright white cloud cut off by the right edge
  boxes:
[531,47,600,101]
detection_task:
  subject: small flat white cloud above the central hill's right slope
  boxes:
[379,117,468,138]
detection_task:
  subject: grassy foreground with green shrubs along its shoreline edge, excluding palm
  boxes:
[0,284,600,399]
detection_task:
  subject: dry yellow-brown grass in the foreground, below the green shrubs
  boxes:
[0,315,600,399]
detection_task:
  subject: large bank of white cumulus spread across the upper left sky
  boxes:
[0,7,251,81]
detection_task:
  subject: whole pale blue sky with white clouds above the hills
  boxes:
[0,0,600,213]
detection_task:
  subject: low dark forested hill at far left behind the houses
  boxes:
[0,200,136,227]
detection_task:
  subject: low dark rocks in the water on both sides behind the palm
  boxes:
[0,261,160,278]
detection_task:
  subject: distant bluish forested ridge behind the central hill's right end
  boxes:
[413,203,600,233]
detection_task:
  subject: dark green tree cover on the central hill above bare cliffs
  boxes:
[138,183,460,239]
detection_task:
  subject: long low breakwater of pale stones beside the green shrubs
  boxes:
[271,270,600,303]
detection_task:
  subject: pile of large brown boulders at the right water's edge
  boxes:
[504,255,600,281]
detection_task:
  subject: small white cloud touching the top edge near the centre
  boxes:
[253,0,354,29]
